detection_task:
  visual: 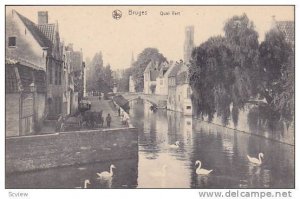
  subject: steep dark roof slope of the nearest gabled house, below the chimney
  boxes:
[15,11,51,47]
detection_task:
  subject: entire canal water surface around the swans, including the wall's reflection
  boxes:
[6,100,295,189]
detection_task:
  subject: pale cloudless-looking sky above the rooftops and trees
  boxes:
[6,6,294,69]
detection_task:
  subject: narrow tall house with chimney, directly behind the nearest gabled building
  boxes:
[36,11,64,120]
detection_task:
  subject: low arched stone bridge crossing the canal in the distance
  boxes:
[118,93,168,108]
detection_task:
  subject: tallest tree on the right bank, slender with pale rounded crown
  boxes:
[224,14,259,108]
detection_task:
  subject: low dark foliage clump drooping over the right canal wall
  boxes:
[248,105,284,138]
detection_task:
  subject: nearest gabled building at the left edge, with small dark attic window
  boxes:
[5,10,49,137]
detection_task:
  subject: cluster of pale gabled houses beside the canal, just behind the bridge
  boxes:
[144,60,192,115]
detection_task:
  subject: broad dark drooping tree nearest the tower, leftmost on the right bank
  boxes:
[189,36,234,123]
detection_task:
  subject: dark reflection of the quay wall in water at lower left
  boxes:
[6,159,138,189]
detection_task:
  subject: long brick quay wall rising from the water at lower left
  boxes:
[5,128,138,173]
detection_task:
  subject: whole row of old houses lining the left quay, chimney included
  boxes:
[5,10,85,137]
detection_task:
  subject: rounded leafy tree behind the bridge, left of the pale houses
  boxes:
[131,48,166,92]
